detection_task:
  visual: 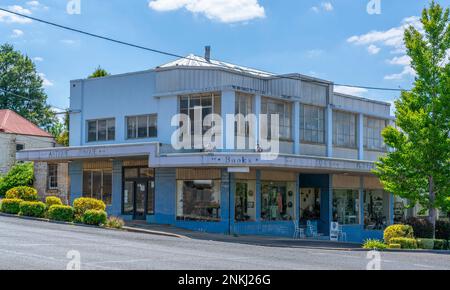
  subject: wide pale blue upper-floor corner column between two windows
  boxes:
[221,90,236,150]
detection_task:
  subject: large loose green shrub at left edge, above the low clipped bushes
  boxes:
[0,162,34,196]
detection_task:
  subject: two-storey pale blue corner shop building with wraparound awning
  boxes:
[18,50,396,241]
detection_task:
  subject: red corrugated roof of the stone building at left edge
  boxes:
[0,110,53,138]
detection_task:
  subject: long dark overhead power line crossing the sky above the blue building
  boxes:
[0,8,406,92]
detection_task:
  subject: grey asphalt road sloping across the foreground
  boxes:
[0,216,450,270]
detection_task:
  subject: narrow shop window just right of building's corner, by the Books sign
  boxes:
[234,180,256,222]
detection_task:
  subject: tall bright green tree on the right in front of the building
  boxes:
[375,0,450,238]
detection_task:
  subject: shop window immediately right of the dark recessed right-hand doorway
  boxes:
[333,189,360,225]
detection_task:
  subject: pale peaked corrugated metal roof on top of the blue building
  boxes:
[157,54,273,77]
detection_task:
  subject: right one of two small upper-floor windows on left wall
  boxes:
[126,114,158,139]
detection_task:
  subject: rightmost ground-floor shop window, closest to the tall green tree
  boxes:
[364,189,389,230]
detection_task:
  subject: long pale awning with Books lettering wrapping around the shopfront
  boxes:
[16,143,374,173]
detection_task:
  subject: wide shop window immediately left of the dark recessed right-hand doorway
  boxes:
[261,181,296,221]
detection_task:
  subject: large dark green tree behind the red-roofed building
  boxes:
[0,44,56,129]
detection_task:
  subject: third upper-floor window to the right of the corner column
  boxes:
[300,105,325,144]
